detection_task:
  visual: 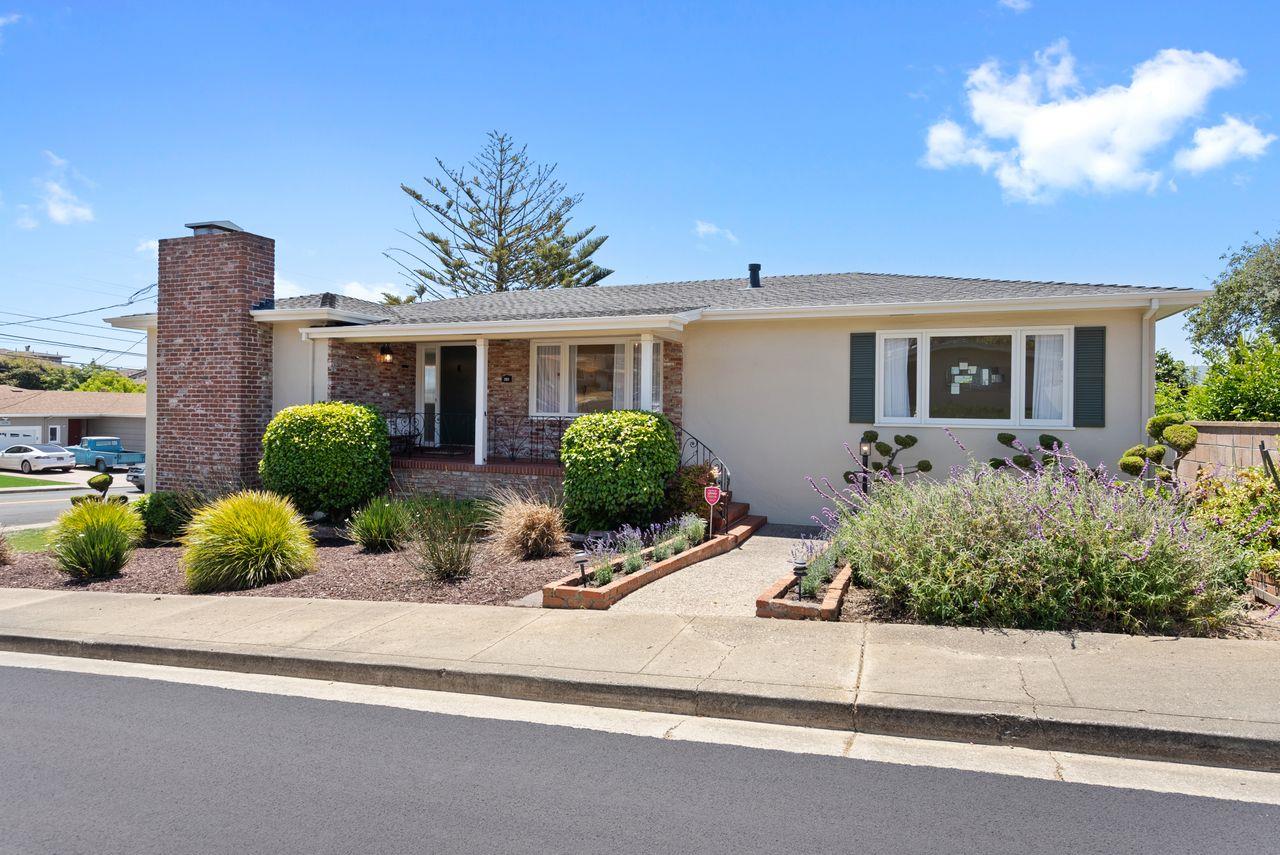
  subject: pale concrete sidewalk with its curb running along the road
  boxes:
[0,589,1280,771]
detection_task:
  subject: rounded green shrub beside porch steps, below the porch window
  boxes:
[561,410,680,531]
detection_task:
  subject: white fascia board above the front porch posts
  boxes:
[302,310,701,342]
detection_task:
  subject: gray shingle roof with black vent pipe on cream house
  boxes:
[360,273,1192,324]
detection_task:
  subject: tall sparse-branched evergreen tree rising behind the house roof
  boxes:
[385,131,613,303]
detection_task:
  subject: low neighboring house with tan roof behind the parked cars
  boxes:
[0,385,147,451]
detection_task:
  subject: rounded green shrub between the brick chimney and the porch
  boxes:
[259,401,390,517]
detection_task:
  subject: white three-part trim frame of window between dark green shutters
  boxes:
[876,326,1075,429]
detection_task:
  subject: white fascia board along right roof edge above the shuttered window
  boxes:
[700,291,1212,321]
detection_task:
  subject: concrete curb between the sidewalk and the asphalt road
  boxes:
[0,631,1280,772]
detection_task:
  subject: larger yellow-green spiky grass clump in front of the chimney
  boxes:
[180,490,316,594]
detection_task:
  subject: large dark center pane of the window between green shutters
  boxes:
[929,335,1014,420]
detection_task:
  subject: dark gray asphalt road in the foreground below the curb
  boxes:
[0,668,1280,855]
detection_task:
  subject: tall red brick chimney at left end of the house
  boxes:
[155,220,275,490]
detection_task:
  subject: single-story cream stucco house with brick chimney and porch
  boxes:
[104,221,1207,522]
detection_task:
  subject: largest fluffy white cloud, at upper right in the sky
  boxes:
[922,40,1265,201]
